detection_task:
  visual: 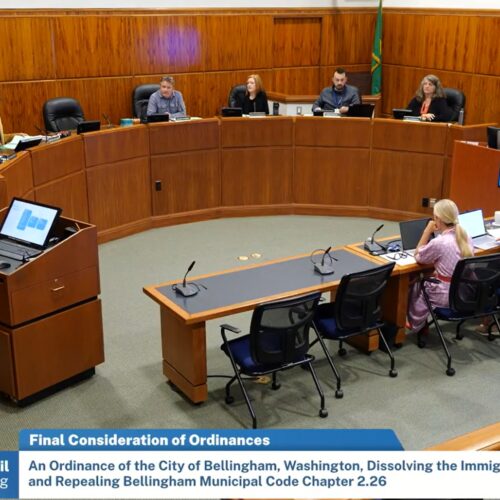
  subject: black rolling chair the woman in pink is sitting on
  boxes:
[417,254,500,377]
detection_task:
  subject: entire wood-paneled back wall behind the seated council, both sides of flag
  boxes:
[0,9,500,133]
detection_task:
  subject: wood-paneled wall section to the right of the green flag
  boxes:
[382,9,500,124]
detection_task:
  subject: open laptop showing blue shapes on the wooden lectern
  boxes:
[0,198,61,261]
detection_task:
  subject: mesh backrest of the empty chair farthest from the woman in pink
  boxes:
[250,292,321,365]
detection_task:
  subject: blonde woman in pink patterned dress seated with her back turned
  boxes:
[408,199,474,335]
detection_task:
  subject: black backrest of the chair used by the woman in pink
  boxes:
[449,254,500,314]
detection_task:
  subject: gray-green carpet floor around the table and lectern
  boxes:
[0,216,500,450]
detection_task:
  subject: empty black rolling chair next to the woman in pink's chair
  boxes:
[311,262,398,398]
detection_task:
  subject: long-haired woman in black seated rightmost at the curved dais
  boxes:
[407,75,452,122]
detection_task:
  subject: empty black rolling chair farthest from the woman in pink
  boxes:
[221,292,328,429]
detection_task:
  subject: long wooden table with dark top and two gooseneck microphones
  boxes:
[143,247,400,403]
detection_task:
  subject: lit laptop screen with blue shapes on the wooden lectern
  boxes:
[0,198,61,248]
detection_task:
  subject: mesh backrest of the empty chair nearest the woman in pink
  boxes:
[335,262,395,331]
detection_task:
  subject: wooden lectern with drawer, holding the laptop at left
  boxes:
[0,210,104,406]
